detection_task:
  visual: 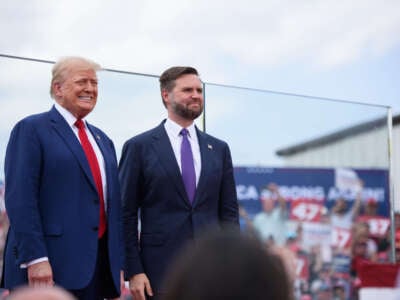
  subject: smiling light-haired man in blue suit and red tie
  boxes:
[3,57,123,300]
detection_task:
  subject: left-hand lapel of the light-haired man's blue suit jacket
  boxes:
[49,107,97,191]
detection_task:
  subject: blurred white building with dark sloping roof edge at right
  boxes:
[276,115,400,210]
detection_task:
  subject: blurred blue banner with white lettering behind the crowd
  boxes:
[234,167,390,222]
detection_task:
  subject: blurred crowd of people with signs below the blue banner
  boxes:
[239,183,400,300]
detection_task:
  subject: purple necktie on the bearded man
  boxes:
[181,128,196,202]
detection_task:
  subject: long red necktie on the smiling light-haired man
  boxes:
[75,119,107,238]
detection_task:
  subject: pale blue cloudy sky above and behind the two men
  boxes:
[0,0,400,170]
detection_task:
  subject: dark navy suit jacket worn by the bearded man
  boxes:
[119,122,239,292]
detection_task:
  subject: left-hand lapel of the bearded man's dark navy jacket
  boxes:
[153,122,190,205]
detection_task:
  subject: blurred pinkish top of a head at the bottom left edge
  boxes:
[7,287,76,300]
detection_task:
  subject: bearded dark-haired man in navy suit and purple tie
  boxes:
[120,67,239,300]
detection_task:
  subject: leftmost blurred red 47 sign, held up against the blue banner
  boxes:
[290,199,323,222]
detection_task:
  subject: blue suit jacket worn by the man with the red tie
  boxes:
[3,107,123,290]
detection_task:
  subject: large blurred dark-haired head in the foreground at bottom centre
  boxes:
[164,232,292,300]
